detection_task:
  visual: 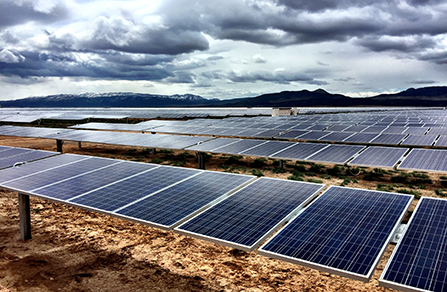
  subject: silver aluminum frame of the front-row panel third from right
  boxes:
[174,178,326,252]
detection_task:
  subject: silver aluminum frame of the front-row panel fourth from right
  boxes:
[114,170,257,231]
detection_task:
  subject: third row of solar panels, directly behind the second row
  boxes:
[72,121,447,147]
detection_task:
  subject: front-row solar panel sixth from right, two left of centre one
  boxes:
[33,161,157,200]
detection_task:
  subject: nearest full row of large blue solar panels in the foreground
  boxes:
[0,154,447,291]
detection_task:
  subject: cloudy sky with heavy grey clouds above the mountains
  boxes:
[0,0,447,100]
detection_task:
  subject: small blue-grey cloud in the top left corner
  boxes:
[0,0,69,29]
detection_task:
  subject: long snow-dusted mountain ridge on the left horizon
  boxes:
[0,92,219,107]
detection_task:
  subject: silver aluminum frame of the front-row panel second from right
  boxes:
[258,186,414,283]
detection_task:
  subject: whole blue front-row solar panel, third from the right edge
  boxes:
[176,178,324,251]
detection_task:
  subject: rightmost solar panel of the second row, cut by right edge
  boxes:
[397,149,447,171]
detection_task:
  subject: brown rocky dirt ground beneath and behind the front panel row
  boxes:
[0,137,442,292]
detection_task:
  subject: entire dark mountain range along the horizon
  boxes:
[0,86,447,107]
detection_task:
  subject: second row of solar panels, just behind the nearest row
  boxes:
[0,126,447,172]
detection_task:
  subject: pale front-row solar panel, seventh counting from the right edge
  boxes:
[2,157,118,191]
